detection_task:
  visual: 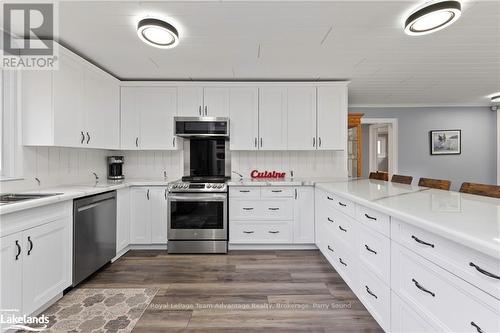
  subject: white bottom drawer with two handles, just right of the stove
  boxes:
[229,221,292,244]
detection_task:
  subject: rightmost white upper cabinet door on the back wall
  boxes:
[317,86,347,150]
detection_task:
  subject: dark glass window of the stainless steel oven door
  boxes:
[170,201,224,229]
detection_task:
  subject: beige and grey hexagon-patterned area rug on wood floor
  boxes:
[21,288,158,333]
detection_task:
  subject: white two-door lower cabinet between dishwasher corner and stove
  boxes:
[130,186,168,244]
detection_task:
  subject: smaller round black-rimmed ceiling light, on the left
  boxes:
[137,18,179,49]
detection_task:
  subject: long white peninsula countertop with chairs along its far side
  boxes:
[316,179,500,258]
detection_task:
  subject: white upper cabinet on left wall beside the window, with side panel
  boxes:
[21,46,120,149]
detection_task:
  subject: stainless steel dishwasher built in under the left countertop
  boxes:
[73,191,116,287]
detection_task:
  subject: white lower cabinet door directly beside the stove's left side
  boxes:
[151,187,167,244]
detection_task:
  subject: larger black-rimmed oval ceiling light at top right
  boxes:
[405,1,462,36]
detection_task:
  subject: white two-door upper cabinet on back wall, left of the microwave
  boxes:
[121,87,178,150]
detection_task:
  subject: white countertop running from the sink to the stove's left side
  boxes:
[0,178,174,215]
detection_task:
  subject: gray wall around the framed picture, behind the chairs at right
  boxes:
[349,107,497,190]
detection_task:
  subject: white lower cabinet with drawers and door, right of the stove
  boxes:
[229,186,314,244]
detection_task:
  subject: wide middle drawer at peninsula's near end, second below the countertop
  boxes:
[391,242,500,332]
